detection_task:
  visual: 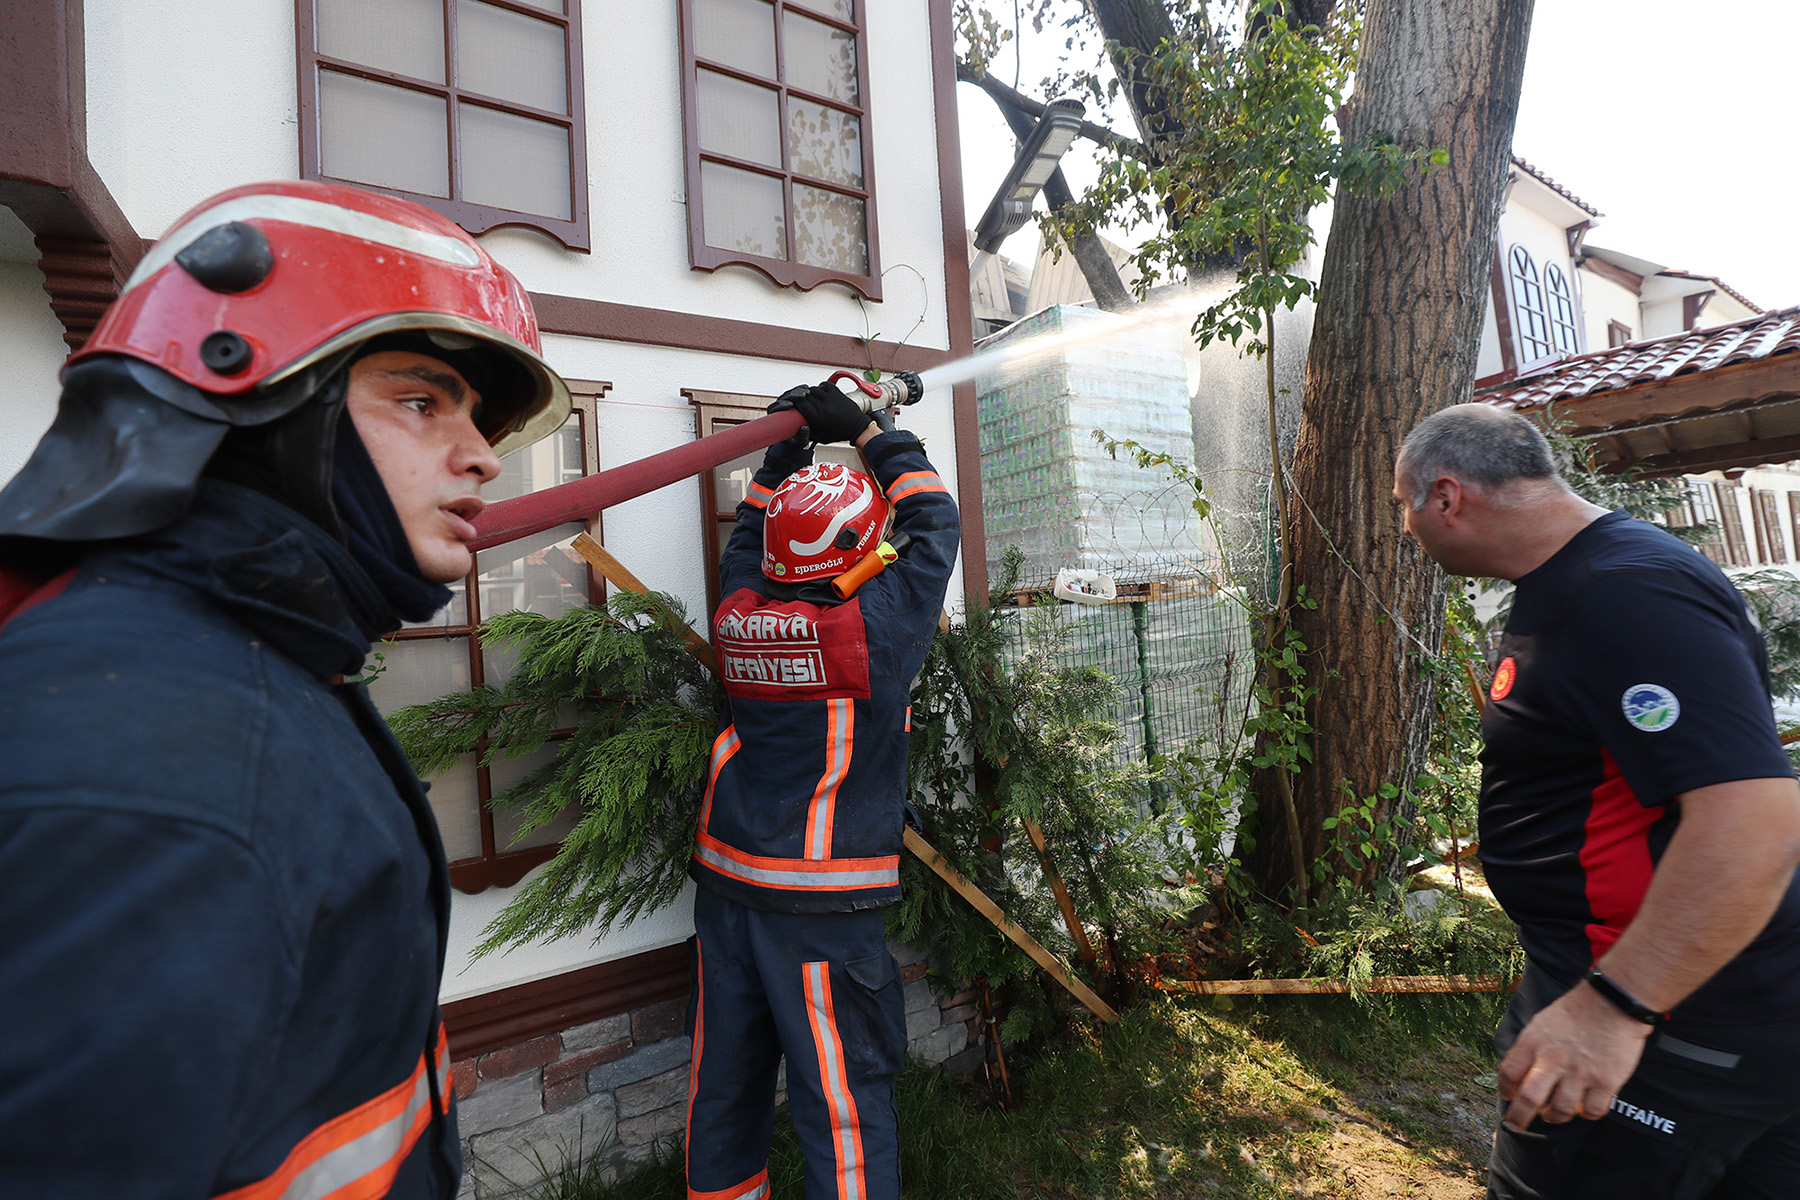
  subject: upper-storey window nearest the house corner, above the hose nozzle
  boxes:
[680,0,880,300]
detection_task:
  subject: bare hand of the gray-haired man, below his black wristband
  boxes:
[1499,984,1651,1130]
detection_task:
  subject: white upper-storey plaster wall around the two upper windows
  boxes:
[86,0,950,349]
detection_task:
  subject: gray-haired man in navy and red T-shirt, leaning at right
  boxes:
[1393,405,1800,1200]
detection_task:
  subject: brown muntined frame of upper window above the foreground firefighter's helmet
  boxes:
[293,0,592,252]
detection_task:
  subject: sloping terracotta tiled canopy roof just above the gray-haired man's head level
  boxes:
[1474,306,1800,408]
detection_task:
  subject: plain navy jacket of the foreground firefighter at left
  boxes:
[0,480,461,1200]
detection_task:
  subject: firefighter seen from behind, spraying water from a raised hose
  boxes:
[688,385,959,1200]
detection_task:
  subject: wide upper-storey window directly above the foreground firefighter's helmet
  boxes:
[297,0,589,250]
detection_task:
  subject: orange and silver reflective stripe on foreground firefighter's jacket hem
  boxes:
[216,1024,450,1200]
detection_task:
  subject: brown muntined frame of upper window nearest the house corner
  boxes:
[680,0,882,300]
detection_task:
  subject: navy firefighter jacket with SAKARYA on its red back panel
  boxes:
[689,430,961,912]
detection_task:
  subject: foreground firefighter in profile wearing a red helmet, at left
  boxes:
[0,182,569,1200]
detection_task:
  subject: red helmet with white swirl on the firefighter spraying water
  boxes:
[763,462,887,583]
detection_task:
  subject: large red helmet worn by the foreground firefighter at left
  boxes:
[68,180,569,453]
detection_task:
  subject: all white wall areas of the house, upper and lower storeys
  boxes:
[17,0,963,1000]
